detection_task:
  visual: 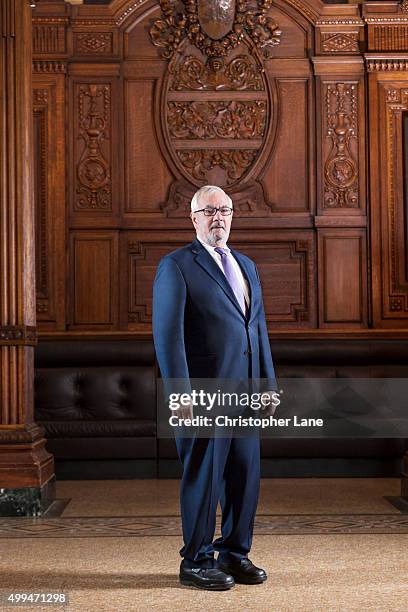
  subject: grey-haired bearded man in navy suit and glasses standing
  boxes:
[153,185,276,590]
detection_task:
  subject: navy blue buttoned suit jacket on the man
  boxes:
[153,239,277,390]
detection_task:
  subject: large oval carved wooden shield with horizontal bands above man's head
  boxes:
[161,45,273,206]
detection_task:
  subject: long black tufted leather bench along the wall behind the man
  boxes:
[35,338,408,478]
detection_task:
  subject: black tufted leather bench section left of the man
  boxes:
[34,340,157,476]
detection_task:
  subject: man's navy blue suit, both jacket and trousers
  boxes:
[153,240,276,567]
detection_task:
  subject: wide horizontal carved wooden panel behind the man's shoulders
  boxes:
[121,230,316,331]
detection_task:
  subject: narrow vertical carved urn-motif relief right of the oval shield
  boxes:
[324,83,359,208]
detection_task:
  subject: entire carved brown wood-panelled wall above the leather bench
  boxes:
[33,0,408,332]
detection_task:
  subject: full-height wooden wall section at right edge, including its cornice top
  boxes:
[363,0,408,330]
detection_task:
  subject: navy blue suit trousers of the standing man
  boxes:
[176,431,260,567]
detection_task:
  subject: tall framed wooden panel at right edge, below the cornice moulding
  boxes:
[369,70,408,327]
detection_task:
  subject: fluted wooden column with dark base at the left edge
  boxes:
[0,0,55,516]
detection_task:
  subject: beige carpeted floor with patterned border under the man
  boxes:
[0,479,408,612]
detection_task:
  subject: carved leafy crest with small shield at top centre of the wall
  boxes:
[150,0,281,58]
